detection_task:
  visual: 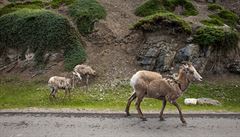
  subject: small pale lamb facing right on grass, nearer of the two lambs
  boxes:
[48,72,82,98]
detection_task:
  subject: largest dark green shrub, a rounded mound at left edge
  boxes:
[0,9,86,69]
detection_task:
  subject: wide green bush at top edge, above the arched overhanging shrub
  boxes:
[135,0,198,17]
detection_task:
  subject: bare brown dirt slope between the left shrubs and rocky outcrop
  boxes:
[82,0,146,82]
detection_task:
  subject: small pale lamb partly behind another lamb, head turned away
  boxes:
[73,64,96,86]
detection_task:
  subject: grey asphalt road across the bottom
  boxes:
[0,114,240,137]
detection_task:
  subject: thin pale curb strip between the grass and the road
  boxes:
[0,111,240,119]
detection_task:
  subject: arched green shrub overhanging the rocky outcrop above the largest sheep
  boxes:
[132,12,191,34]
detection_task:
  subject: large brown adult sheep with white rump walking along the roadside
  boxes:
[125,62,202,123]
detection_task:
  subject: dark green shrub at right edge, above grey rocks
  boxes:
[194,26,239,51]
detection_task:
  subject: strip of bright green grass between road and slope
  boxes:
[0,81,240,113]
